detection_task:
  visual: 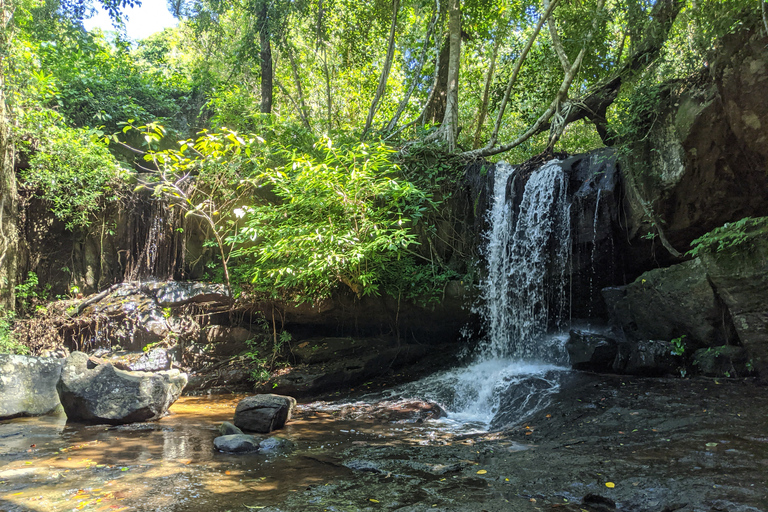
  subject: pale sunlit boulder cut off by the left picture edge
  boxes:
[0,354,64,420]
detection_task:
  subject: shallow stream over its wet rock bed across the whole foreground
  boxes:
[0,372,768,512]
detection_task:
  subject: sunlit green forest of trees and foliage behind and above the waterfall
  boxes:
[0,0,768,348]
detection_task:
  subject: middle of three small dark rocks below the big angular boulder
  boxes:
[613,340,684,377]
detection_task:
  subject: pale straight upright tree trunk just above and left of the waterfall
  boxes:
[434,0,461,151]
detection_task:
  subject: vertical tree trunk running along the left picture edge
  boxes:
[0,0,18,311]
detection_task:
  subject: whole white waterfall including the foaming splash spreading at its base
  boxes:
[368,160,571,429]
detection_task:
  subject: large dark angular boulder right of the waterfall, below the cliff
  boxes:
[603,259,732,347]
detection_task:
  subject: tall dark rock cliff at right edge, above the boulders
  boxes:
[624,31,768,266]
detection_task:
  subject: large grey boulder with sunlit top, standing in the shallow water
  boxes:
[57,352,187,424]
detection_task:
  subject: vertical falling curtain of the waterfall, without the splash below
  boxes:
[481,160,571,359]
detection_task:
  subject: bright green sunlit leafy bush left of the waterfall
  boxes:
[230,139,424,301]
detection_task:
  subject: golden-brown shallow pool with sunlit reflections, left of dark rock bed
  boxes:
[0,396,492,512]
